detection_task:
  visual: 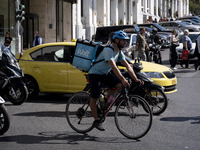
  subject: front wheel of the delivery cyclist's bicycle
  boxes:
[115,95,152,139]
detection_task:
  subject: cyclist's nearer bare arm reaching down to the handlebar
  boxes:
[108,59,129,86]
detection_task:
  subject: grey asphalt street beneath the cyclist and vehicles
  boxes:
[0,49,200,150]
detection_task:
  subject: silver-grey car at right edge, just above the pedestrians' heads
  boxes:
[158,21,200,32]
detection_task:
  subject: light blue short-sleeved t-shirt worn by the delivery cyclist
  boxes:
[88,47,125,75]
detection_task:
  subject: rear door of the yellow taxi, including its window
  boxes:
[30,45,68,92]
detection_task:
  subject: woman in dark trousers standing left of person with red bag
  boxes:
[170,29,179,70]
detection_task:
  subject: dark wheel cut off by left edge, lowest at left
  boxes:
[0,104,10,135]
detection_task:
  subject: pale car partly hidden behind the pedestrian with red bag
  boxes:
[169,32,200,63]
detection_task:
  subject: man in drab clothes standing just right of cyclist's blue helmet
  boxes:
[135,27,149,61]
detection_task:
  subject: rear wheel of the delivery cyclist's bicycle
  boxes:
[65,91,94,133]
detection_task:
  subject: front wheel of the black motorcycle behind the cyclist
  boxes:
[144,89,168,115]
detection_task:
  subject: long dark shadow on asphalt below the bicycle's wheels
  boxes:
[0,131,138,145]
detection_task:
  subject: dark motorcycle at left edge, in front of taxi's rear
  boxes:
[0,45,28,105]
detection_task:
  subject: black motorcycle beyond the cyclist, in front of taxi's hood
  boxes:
[120,59,168,115]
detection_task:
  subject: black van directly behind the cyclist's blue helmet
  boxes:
[94,25,140,44]
